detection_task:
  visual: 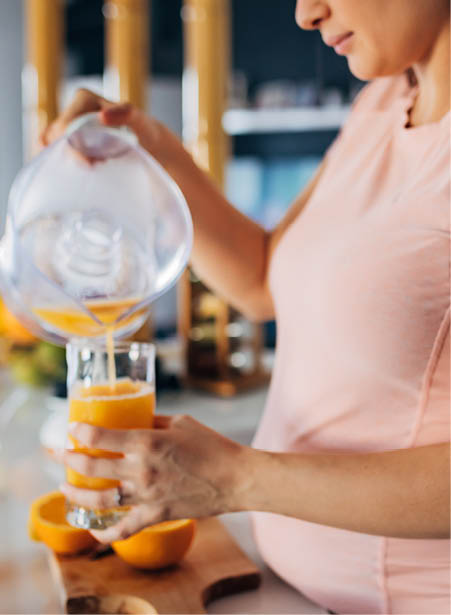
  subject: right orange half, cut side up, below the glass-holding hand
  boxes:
[111,519,196,570]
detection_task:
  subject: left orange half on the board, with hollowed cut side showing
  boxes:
[28,491,97,555]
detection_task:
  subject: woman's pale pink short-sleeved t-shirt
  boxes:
[254,76,450,615]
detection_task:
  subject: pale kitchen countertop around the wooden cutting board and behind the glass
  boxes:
[0,372,326,615]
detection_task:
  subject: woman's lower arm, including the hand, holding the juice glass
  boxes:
[60,415,450,542]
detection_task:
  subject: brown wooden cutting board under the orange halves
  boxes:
[50,518,261,614]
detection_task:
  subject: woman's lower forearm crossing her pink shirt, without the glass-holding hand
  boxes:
[238,444,450,538]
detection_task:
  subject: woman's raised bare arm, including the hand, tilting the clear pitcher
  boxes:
[42,89,326,320]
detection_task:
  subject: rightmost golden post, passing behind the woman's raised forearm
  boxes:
[179,0,266,396]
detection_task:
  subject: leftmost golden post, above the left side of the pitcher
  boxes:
[25,0,64,152]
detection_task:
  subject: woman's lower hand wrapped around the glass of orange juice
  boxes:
[59,415,252,543]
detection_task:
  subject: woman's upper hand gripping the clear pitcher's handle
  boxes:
[40,89,178,166]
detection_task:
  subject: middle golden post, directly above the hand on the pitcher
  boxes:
[104,0,150,111]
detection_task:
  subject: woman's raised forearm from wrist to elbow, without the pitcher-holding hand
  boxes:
[155,126,273,319]
